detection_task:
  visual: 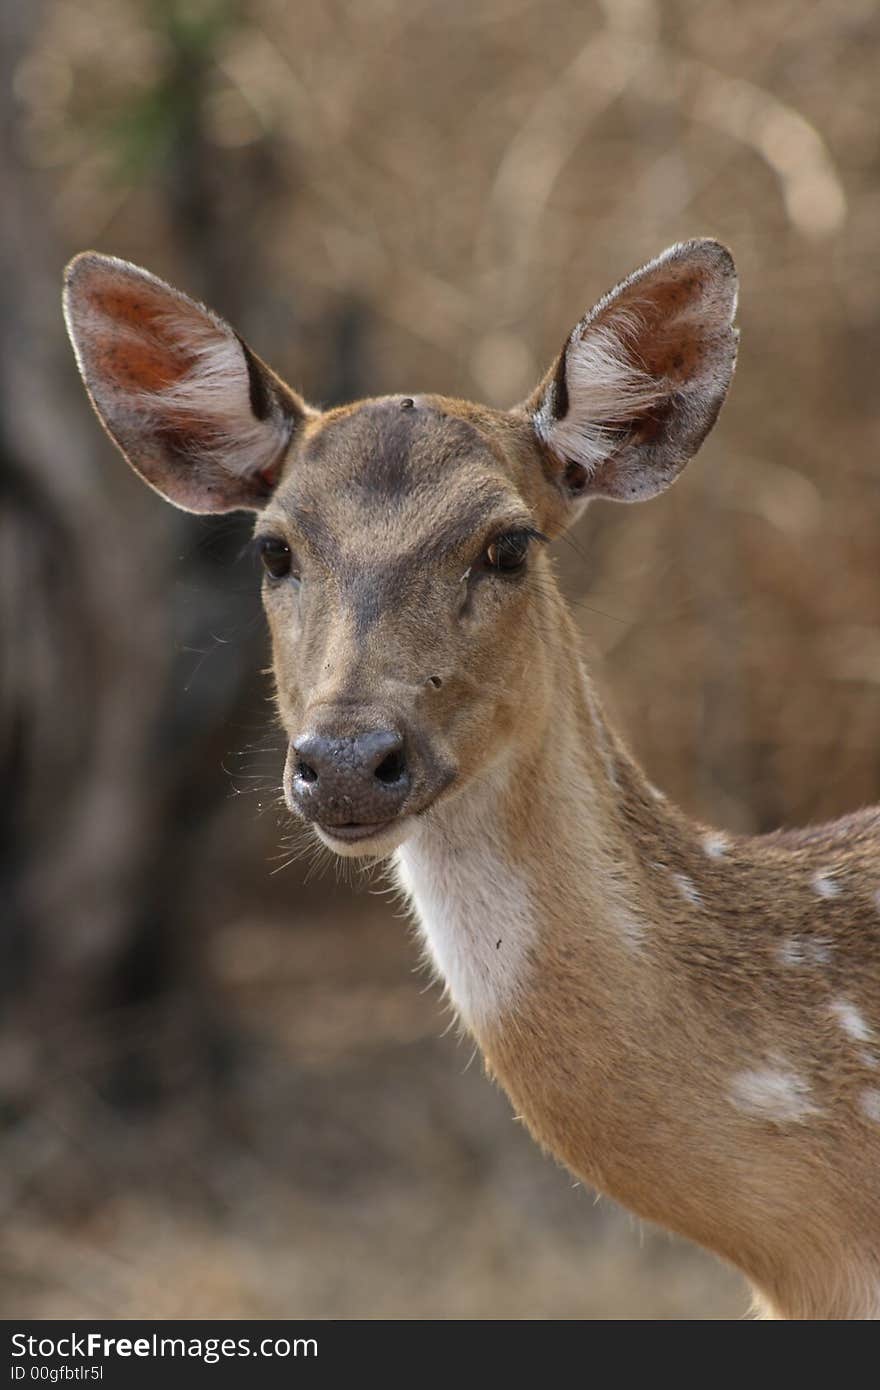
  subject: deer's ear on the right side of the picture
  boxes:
[525,240,738,502]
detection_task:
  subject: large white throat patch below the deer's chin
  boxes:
[395,774,537,1030]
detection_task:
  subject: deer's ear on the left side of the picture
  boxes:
[64,252,310,512]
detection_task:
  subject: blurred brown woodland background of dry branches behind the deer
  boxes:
[0,0,880,1318]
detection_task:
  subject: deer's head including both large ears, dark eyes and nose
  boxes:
[64,240,737,856]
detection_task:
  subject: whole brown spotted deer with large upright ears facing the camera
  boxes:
[64,238,880,1319]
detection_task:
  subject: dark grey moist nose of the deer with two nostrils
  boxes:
[291,728,410,826]
